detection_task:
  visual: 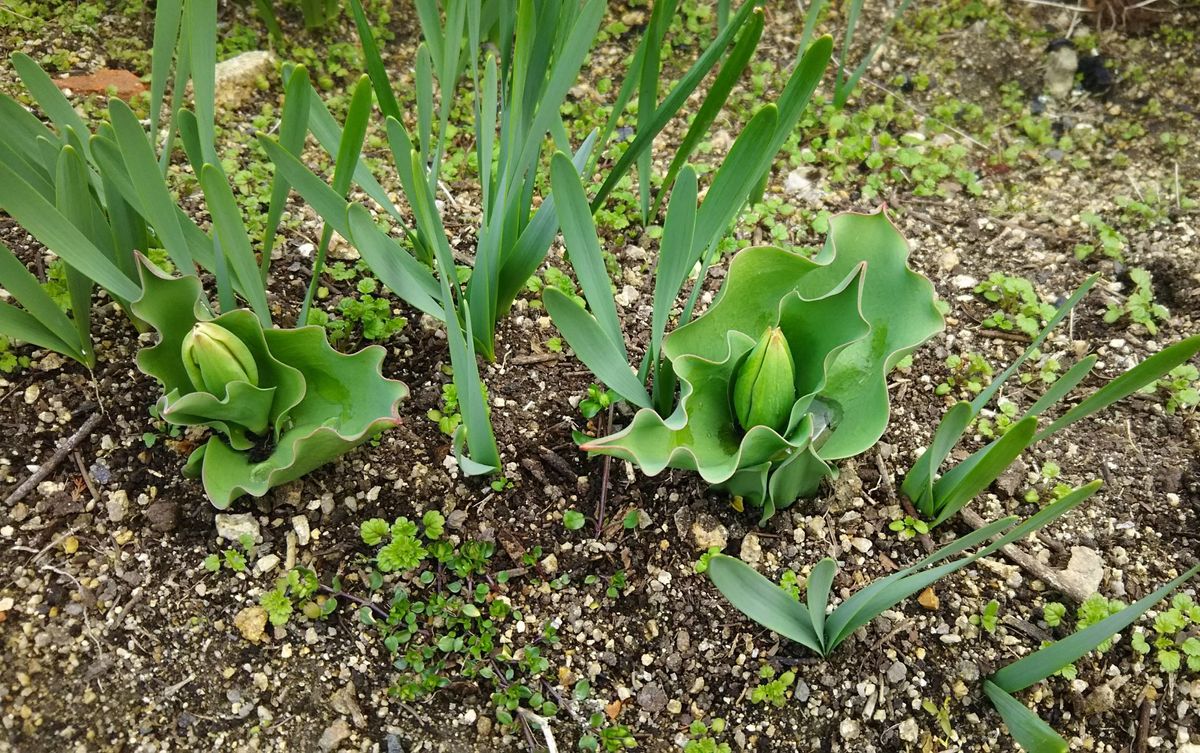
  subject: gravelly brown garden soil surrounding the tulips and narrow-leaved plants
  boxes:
[0,0,1200,753]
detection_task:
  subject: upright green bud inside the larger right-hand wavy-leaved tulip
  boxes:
[733,327,796,433]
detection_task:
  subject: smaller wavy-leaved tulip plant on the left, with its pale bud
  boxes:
[132,259,408,508]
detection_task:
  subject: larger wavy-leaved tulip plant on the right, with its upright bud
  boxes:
[580,212,943,519]
